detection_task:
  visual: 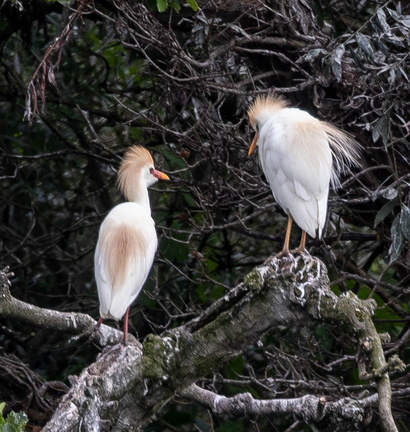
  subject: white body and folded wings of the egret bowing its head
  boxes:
[258,108,332,237]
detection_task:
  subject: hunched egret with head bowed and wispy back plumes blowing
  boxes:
[248,95,360,255]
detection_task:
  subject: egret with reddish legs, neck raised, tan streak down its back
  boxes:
[94,146,169,344]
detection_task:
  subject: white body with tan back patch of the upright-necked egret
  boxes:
[94,202,158,320]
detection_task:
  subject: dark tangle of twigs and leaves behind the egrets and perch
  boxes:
[0,0,410,432]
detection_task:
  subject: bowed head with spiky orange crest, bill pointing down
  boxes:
[248,94,288,155]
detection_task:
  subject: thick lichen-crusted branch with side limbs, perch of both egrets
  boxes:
[0,255,401,432]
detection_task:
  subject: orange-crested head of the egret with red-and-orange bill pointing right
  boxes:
[118,146,169,201]
